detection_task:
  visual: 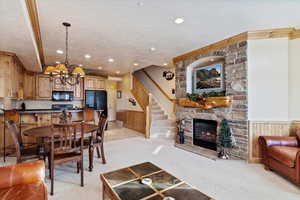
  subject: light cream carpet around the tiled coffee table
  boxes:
[0,130,300,200]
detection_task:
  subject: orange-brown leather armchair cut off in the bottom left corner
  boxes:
[0,161,48,200]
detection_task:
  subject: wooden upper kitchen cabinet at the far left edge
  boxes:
[0,52,24,99]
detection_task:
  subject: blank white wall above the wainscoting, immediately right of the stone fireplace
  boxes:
[247,38,289,121]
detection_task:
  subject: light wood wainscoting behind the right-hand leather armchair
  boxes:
[248,121,291,163]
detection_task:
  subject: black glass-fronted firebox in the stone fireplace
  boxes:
[193,119,218,151]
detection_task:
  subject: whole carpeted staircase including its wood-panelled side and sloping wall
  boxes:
[132,70,177,141]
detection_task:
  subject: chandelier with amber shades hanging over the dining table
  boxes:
[44,22,85,86]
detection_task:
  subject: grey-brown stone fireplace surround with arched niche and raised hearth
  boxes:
[175,41,248,159]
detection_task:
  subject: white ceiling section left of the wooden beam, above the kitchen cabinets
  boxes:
[0,0,41,71]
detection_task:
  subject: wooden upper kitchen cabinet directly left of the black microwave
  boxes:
[36,74,52,100]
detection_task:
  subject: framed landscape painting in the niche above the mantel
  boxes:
[193,63,224,93]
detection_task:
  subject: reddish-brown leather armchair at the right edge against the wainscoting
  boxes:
[258,136,300,184]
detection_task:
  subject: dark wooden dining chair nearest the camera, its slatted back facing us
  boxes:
[49,122,84,195]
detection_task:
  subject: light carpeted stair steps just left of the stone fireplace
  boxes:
[150,98,177,140]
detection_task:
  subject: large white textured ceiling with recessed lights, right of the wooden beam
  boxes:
[0,0,300,73]
